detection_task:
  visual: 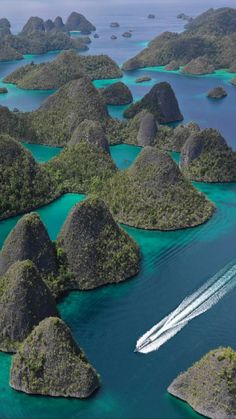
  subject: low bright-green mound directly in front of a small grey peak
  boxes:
[45,140,116,193]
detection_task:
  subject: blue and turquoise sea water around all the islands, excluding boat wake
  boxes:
[0,0,236,419]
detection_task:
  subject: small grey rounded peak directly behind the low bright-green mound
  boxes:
[68,119,110,154]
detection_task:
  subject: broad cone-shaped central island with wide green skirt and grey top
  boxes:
[94,147,214,230]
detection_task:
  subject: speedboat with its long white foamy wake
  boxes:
[136,263,236,353]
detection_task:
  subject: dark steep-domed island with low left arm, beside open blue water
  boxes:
[124,82,183,123]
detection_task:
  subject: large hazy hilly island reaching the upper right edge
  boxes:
[123,7,236,74]
